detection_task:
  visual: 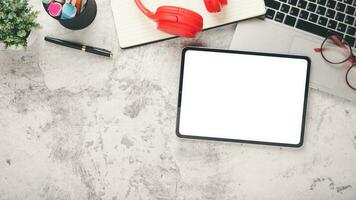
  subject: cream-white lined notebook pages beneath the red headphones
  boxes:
[111,0,266,48]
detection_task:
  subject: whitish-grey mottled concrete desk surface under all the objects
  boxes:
[0,0,356,200]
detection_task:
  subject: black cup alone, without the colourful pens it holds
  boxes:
[44,0,97,30]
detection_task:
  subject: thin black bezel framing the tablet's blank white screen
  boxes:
[176,47,311,148]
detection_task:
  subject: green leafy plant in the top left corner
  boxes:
[0,0,40,48]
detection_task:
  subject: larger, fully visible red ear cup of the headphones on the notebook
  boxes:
[155,6,203,38]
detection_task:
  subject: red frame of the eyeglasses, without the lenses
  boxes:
[314,34,356,90]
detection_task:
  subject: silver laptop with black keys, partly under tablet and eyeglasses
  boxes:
[230,0,356,102]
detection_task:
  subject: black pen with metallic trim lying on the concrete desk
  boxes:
[45,36,113,57]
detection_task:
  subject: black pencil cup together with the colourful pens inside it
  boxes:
[42,0,97,30]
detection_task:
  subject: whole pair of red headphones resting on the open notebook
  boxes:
[135,0,228,38]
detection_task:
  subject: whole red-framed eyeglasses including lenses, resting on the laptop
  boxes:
[314,34,356,91]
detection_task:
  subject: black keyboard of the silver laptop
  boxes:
[265,0,356,48]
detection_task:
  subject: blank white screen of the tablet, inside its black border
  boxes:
[178,50,308,145]
